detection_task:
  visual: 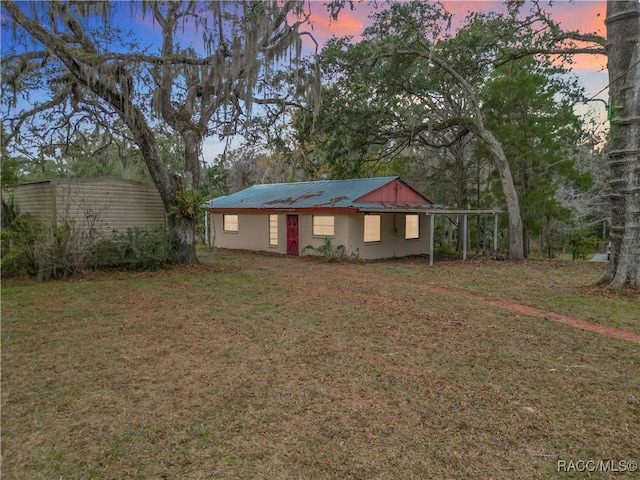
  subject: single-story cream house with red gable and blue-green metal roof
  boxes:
[205,177,438,259]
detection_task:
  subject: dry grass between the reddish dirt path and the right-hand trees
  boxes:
[370,259,640,333]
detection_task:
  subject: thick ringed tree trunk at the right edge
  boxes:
[601,0,640,288]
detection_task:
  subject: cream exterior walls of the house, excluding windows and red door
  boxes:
[210,213,429,260]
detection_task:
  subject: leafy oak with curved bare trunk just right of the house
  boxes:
[304,1,600,260]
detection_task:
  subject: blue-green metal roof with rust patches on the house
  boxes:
[205,177,433,211]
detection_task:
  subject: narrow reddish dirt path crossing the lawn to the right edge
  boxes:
[352,273,640,344]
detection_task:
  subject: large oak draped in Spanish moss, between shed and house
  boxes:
[1,0,314,264]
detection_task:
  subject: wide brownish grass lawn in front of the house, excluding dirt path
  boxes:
[2,251,640,480]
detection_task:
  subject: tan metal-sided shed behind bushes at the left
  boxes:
[3,177,166,236]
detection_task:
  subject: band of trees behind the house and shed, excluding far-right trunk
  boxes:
[2,1,610,263]
